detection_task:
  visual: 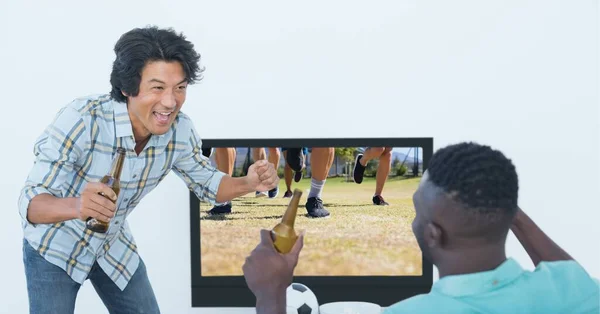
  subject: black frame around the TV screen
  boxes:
[190,137,433,307]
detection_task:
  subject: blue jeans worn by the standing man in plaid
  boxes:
[23,240,160,314]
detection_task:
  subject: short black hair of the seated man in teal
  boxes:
[427,142,519,217]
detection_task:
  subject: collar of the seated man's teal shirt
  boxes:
[432,258,524,297]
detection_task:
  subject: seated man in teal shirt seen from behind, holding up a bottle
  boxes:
[243,143,600,314]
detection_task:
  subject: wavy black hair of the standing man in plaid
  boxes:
[110,26,202,102]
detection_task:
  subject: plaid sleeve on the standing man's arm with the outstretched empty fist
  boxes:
[173,122,225,205]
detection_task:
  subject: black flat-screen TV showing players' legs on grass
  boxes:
[190,138,433,307]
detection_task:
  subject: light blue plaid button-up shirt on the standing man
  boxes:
[19,95,224,290]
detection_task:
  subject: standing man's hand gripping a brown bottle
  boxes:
[78,182,117,223]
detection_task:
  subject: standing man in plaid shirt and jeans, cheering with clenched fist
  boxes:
[19,27,279,313]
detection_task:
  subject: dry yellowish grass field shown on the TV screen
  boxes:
[200,177,422,276]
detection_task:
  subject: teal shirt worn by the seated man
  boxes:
[383,259,600,314]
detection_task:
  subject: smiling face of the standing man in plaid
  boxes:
[123,61,188,141]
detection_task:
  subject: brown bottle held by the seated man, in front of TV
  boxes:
[271,189,302,254]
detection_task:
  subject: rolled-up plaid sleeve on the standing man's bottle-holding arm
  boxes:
[19,107,86,224]
